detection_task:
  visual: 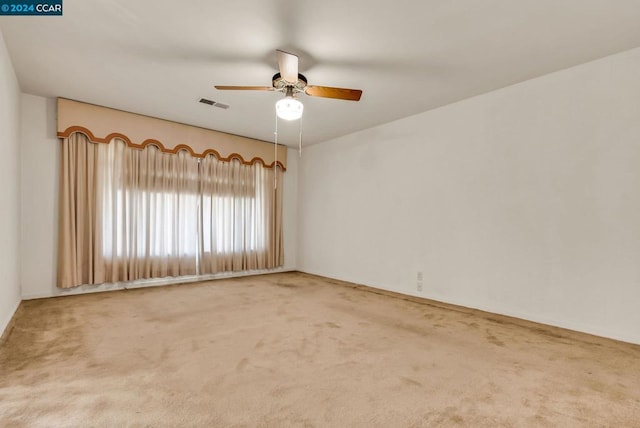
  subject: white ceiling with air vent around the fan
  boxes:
[0,0,640,146]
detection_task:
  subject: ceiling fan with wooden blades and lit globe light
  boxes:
[215,49,362,120]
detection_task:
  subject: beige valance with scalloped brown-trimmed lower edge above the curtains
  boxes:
[58,98,287,169]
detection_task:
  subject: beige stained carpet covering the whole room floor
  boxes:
[0,273,640,427]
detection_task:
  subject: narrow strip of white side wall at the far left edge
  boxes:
[0,32,20,336]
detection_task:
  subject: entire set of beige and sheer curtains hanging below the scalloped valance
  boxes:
[58,133,283,288]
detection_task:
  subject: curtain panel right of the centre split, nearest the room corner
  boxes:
[200,156,283,273]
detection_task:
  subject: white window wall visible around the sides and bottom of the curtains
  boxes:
[20,94,298,299]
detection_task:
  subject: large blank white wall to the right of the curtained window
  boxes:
[298,49,640,343]
